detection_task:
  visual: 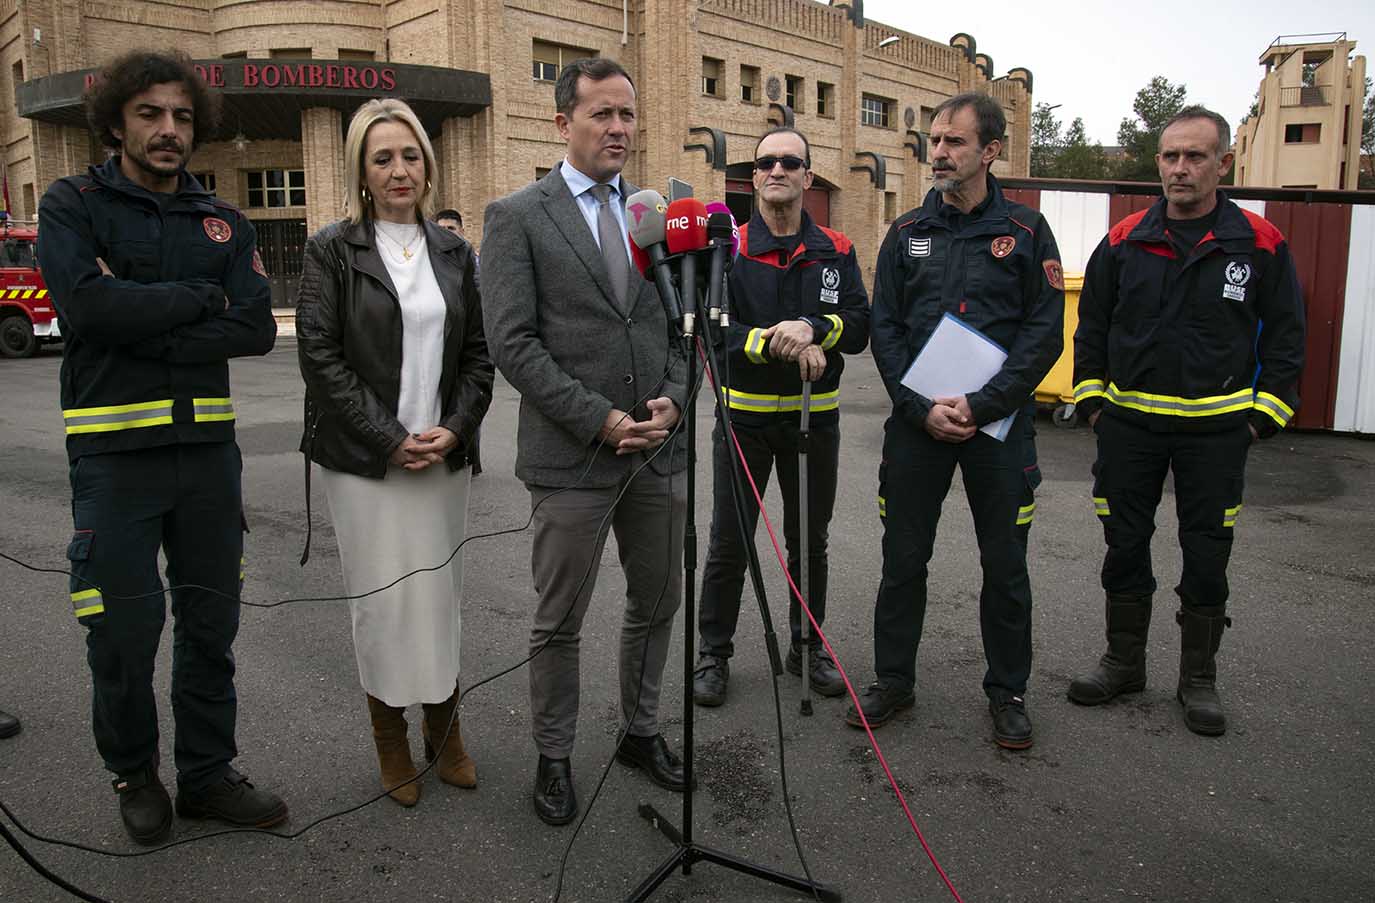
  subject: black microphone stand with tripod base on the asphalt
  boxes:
[626,248,844,903]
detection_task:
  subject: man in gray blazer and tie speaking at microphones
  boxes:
[483,59,688,825]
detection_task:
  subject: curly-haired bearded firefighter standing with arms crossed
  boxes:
[39,51,287,844]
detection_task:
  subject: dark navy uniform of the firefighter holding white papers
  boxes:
[870,176,1064,697]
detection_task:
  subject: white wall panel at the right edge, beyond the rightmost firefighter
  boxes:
[1332,205,1375,433]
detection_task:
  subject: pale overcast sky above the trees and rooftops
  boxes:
[865,0,1375,144]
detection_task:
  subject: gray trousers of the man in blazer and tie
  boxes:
[528,469,688,759]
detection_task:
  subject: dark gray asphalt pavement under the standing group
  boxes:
[0,338,1375,903]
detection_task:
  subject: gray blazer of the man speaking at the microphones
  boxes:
[483,168,688,488]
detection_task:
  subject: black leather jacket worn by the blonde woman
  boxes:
[296,220,494,478]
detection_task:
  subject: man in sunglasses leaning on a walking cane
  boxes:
[693,128,869,705]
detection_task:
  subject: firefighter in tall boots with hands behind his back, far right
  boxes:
[1068,107,1304,735]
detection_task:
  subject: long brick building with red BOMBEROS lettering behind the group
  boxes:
[0,0,1031,302]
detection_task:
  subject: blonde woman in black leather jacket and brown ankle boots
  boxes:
[296,99,492,805]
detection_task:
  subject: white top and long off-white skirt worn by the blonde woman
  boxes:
[315,223,470,706]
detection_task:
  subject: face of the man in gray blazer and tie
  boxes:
[554,76,635,181]
